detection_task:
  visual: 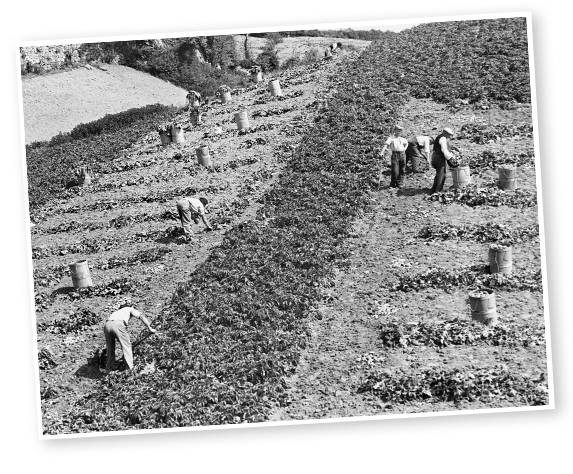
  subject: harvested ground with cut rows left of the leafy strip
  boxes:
[32,50,366,428]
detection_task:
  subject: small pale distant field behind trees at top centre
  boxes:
[235,35,371,62]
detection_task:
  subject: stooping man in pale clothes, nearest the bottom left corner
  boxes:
[103,303,157,373]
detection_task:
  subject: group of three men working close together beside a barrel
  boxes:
[379,125,454,194]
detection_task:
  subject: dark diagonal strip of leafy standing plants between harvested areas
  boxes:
[51,44,405,434]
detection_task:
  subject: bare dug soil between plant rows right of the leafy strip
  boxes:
[271,100,546,421]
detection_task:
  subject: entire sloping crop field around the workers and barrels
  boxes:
[32,17,549,435]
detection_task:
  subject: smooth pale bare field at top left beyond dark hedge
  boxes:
[22,64,186,143]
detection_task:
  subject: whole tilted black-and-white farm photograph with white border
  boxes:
[20,15,552,437]
